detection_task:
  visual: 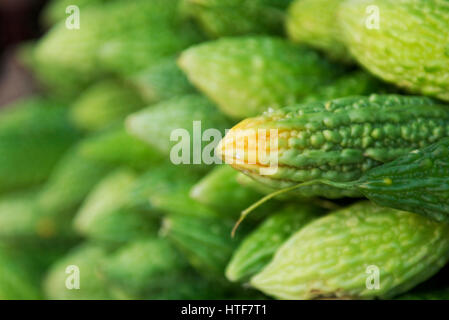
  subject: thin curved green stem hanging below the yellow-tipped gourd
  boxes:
[231,180,356,237]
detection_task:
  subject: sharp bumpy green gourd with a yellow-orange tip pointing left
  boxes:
[217,95,449,198]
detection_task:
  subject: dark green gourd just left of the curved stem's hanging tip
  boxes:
[162,215,245,279]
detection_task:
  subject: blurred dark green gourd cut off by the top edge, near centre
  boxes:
[184,0,291,38]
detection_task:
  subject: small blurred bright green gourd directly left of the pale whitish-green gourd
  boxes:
[80,125,165,171]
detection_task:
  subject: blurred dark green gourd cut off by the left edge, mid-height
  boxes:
[0,98,80,193]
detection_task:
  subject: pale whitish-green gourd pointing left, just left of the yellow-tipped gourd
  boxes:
[126,94,231,169]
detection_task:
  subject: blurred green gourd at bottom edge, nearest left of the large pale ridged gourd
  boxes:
[98,237,233,300]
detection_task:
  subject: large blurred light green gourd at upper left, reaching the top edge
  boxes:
[35,0,192,92]
